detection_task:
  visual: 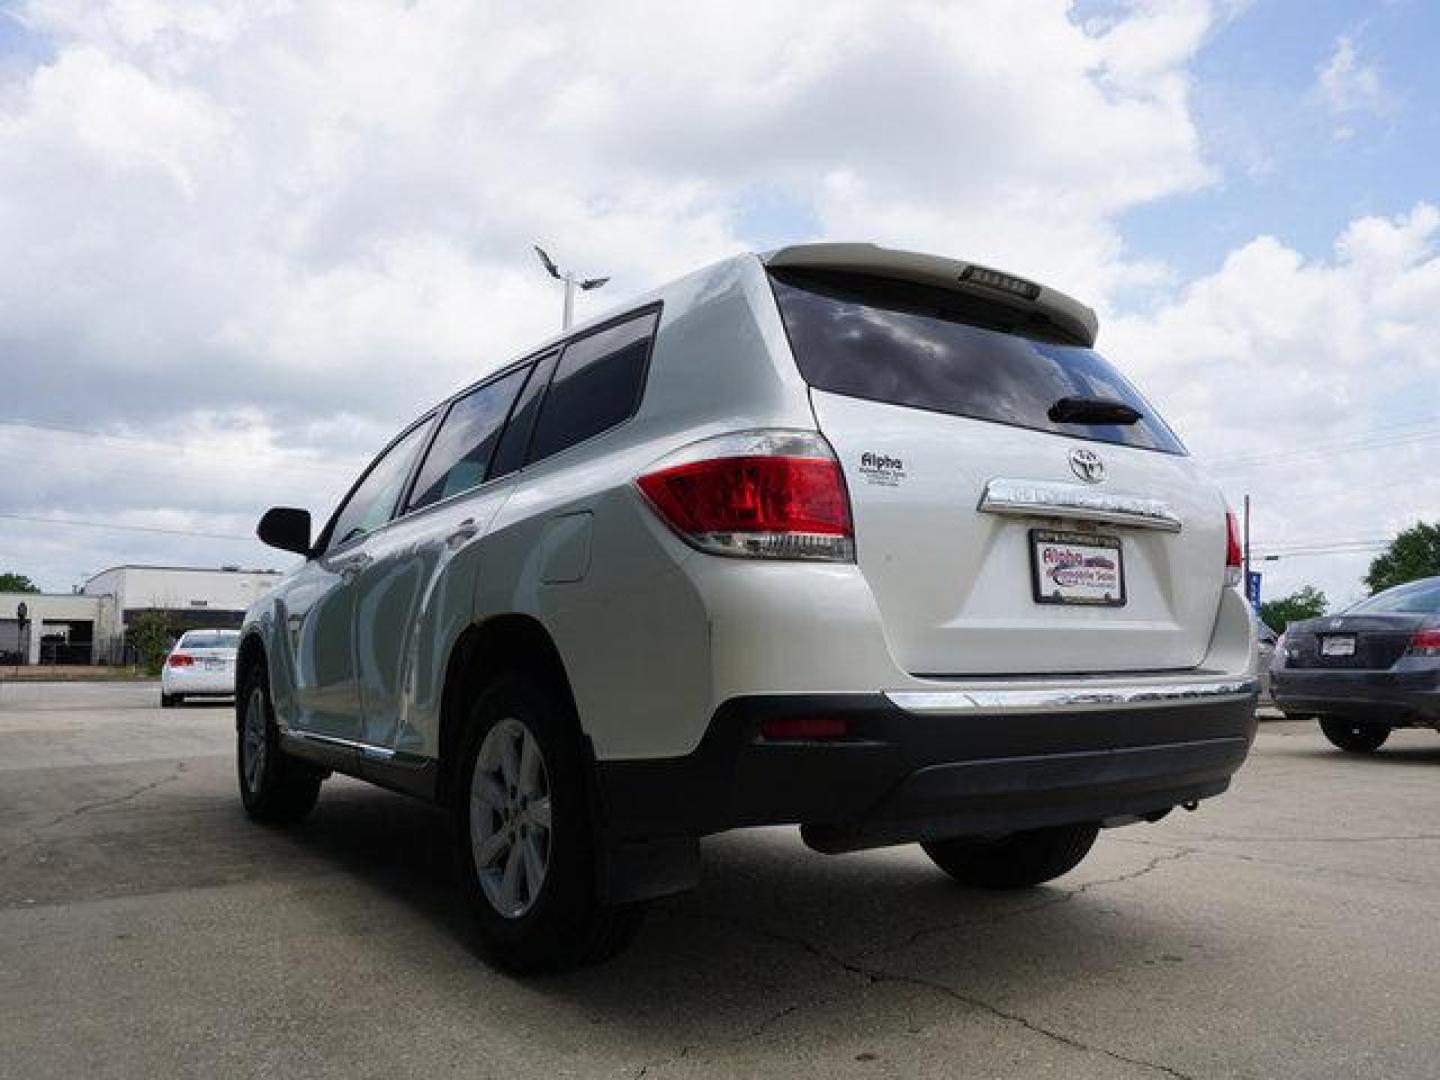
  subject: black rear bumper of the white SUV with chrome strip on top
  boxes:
[599,678,1256,851]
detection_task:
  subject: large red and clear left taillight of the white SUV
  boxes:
[635,431,855,562]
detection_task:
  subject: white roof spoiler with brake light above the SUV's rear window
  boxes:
[760,243,1100,347]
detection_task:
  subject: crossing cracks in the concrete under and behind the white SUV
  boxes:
[659,848,1200,1080]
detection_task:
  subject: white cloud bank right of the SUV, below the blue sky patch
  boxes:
[1102,203,1440,602]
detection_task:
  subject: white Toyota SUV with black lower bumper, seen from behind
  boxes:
[238,245,1257,971]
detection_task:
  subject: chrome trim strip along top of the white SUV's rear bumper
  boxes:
[886,678,1260,716]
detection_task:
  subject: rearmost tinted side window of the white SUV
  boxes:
[530,311,660,461]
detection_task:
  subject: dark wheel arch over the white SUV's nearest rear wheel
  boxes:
[435,612,585,805]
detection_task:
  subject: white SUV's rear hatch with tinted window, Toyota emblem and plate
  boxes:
[772,262,1227,677]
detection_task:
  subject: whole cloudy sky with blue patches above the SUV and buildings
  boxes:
[0,0,1440,603]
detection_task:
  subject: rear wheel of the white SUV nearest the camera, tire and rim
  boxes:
[452,674,642,973]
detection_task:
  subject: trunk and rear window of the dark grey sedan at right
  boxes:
[1284,577,1440,671]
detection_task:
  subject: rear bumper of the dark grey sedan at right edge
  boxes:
[1270,658,1440,724]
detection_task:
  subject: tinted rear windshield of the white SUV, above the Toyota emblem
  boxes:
[772,271,1185,454]
